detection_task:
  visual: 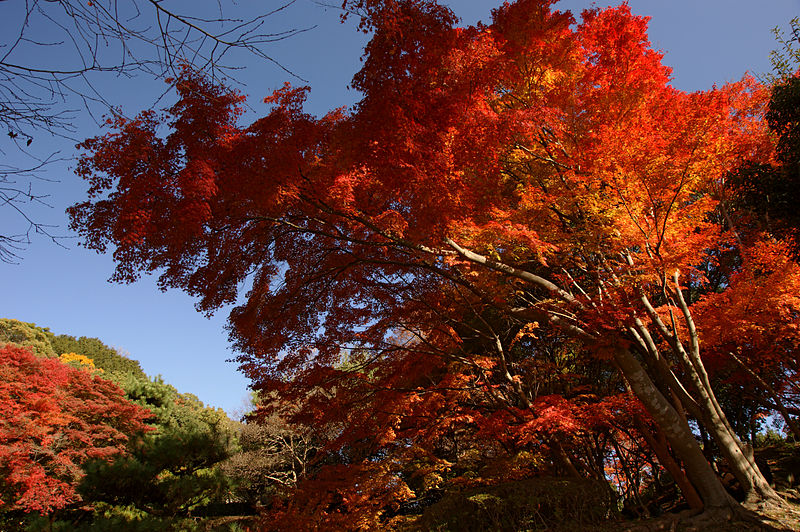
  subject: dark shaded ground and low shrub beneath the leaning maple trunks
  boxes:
[392,443,800,532]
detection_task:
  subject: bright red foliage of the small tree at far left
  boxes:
[0,344,149,514]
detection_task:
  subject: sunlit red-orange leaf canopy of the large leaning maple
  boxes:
[71,0,767,379]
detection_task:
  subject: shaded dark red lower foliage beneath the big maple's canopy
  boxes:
[255,340,646,530]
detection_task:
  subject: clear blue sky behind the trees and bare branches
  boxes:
[0,0,800,412]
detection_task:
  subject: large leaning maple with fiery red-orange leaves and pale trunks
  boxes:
[70,0,797,511]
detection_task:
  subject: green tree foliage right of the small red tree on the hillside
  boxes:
[81,374,241,517]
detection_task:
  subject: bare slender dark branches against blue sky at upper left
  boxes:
[0,0,311,262]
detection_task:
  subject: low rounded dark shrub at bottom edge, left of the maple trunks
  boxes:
[414,477,616,532]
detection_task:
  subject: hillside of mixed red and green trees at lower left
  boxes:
[0,319,252,531]
